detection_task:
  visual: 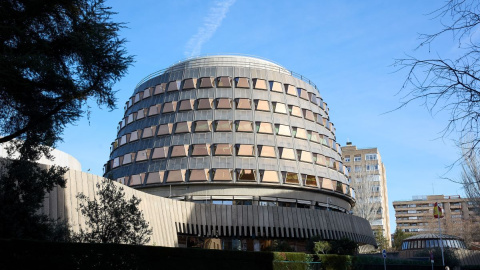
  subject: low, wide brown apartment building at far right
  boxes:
[393,195,478,235]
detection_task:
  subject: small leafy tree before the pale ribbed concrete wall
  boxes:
[73,179,152,245]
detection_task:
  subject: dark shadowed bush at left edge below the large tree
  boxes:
[0,160,68,241]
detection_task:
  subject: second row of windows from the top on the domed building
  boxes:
[118,98,335,133]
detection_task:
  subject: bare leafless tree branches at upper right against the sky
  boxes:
[395,0,480,161]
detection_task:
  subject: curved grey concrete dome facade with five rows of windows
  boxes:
[105,55,375,250]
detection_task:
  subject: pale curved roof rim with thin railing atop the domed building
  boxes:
[135,54,318,90]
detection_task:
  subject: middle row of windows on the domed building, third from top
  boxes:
[111,120,341,153]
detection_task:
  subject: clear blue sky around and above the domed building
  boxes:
[58,0,463,232]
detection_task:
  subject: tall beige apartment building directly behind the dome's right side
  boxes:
[342,142,392,246]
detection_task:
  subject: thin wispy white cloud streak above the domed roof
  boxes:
[185,0,236,57]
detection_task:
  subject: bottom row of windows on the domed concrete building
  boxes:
[117,169,353,195]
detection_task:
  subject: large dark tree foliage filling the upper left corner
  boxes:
[0,0,132,160]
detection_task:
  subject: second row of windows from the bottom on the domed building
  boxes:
[106,144,346,174]
